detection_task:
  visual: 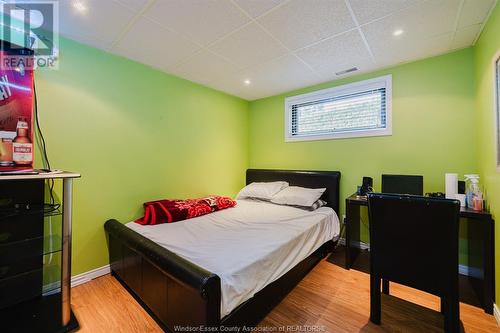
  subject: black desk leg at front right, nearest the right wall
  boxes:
[482,220,495,314]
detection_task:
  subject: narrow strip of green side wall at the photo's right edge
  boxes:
[474,4,500,302]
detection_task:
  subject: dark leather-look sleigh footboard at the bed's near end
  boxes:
[104,220,221,331]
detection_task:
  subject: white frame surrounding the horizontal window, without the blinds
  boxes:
[285,74,392,142]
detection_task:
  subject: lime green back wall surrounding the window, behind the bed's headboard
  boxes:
[249,48,478,248]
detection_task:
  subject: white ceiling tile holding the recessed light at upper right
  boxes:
[361,0,459,66]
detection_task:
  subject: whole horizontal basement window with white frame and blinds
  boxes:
[285,75,392,141]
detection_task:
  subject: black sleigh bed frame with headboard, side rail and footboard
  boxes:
[104,169,340,332]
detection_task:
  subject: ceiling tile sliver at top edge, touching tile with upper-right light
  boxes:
[349,0,424,24]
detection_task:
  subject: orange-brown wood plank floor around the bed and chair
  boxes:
[72,260,500,333]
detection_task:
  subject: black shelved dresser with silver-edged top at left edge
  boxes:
[0,172,80,333]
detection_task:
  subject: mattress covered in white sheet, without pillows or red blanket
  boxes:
[127,200,340,317]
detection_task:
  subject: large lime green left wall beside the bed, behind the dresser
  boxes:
[36,40,248,275]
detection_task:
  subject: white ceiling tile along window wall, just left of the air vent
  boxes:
[240,54,321,98]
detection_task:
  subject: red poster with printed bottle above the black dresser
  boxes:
[0,50,34,172]
